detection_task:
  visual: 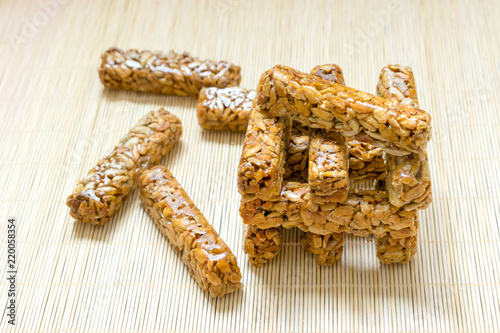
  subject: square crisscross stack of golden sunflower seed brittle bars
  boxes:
[238,66,431,265]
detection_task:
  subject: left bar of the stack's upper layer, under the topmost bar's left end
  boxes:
[238,110,290,200]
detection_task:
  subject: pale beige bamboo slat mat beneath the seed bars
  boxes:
[0,0,500,332]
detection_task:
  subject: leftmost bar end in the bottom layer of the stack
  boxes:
[243,224,282,266]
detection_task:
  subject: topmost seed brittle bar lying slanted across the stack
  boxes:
[253,66,431,155]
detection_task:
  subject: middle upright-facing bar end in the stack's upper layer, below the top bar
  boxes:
[309,129,349,202]
